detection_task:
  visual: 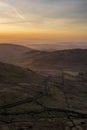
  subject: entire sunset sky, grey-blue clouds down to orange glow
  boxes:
[0,0,87,40]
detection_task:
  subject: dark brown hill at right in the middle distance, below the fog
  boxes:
[21,49,87,71]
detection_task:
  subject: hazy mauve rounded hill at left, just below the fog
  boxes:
[0,43,32,63]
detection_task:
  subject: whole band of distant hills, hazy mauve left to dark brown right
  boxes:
[0,44,87,71]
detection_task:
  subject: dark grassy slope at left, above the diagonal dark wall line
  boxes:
[0,62,44,104]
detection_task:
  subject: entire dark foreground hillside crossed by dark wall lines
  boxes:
[0,62,87,130]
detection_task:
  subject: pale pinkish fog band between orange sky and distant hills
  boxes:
[0,40,87,51]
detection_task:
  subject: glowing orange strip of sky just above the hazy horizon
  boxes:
[0,32,87,40]
